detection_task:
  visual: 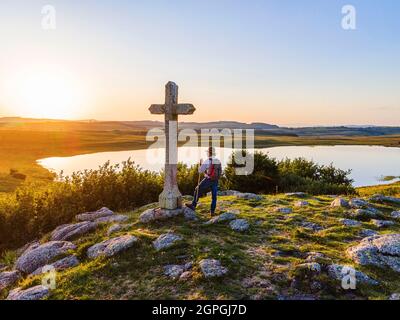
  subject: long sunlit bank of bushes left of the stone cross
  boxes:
[0,160,162,250]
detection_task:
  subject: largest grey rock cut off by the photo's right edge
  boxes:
[346,234,400,272]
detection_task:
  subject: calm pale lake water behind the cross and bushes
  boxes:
[38,146,400,186]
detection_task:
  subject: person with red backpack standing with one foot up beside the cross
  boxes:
[186,147,222,216]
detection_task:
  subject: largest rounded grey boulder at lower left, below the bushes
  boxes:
[16,241,76,273]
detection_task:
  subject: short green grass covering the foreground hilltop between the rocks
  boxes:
[2,190,400,299]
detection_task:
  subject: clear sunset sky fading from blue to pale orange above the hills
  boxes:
[0,0,400,126]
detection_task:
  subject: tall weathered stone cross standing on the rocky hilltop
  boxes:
[149,81,196,210]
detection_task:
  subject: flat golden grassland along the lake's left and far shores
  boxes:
[0,127,400,195]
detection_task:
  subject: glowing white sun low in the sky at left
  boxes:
[8,67,85,119]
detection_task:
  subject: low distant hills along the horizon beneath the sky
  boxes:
[0,117,400,136]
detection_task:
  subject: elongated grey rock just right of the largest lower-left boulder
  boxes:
[87,235,138,259]
